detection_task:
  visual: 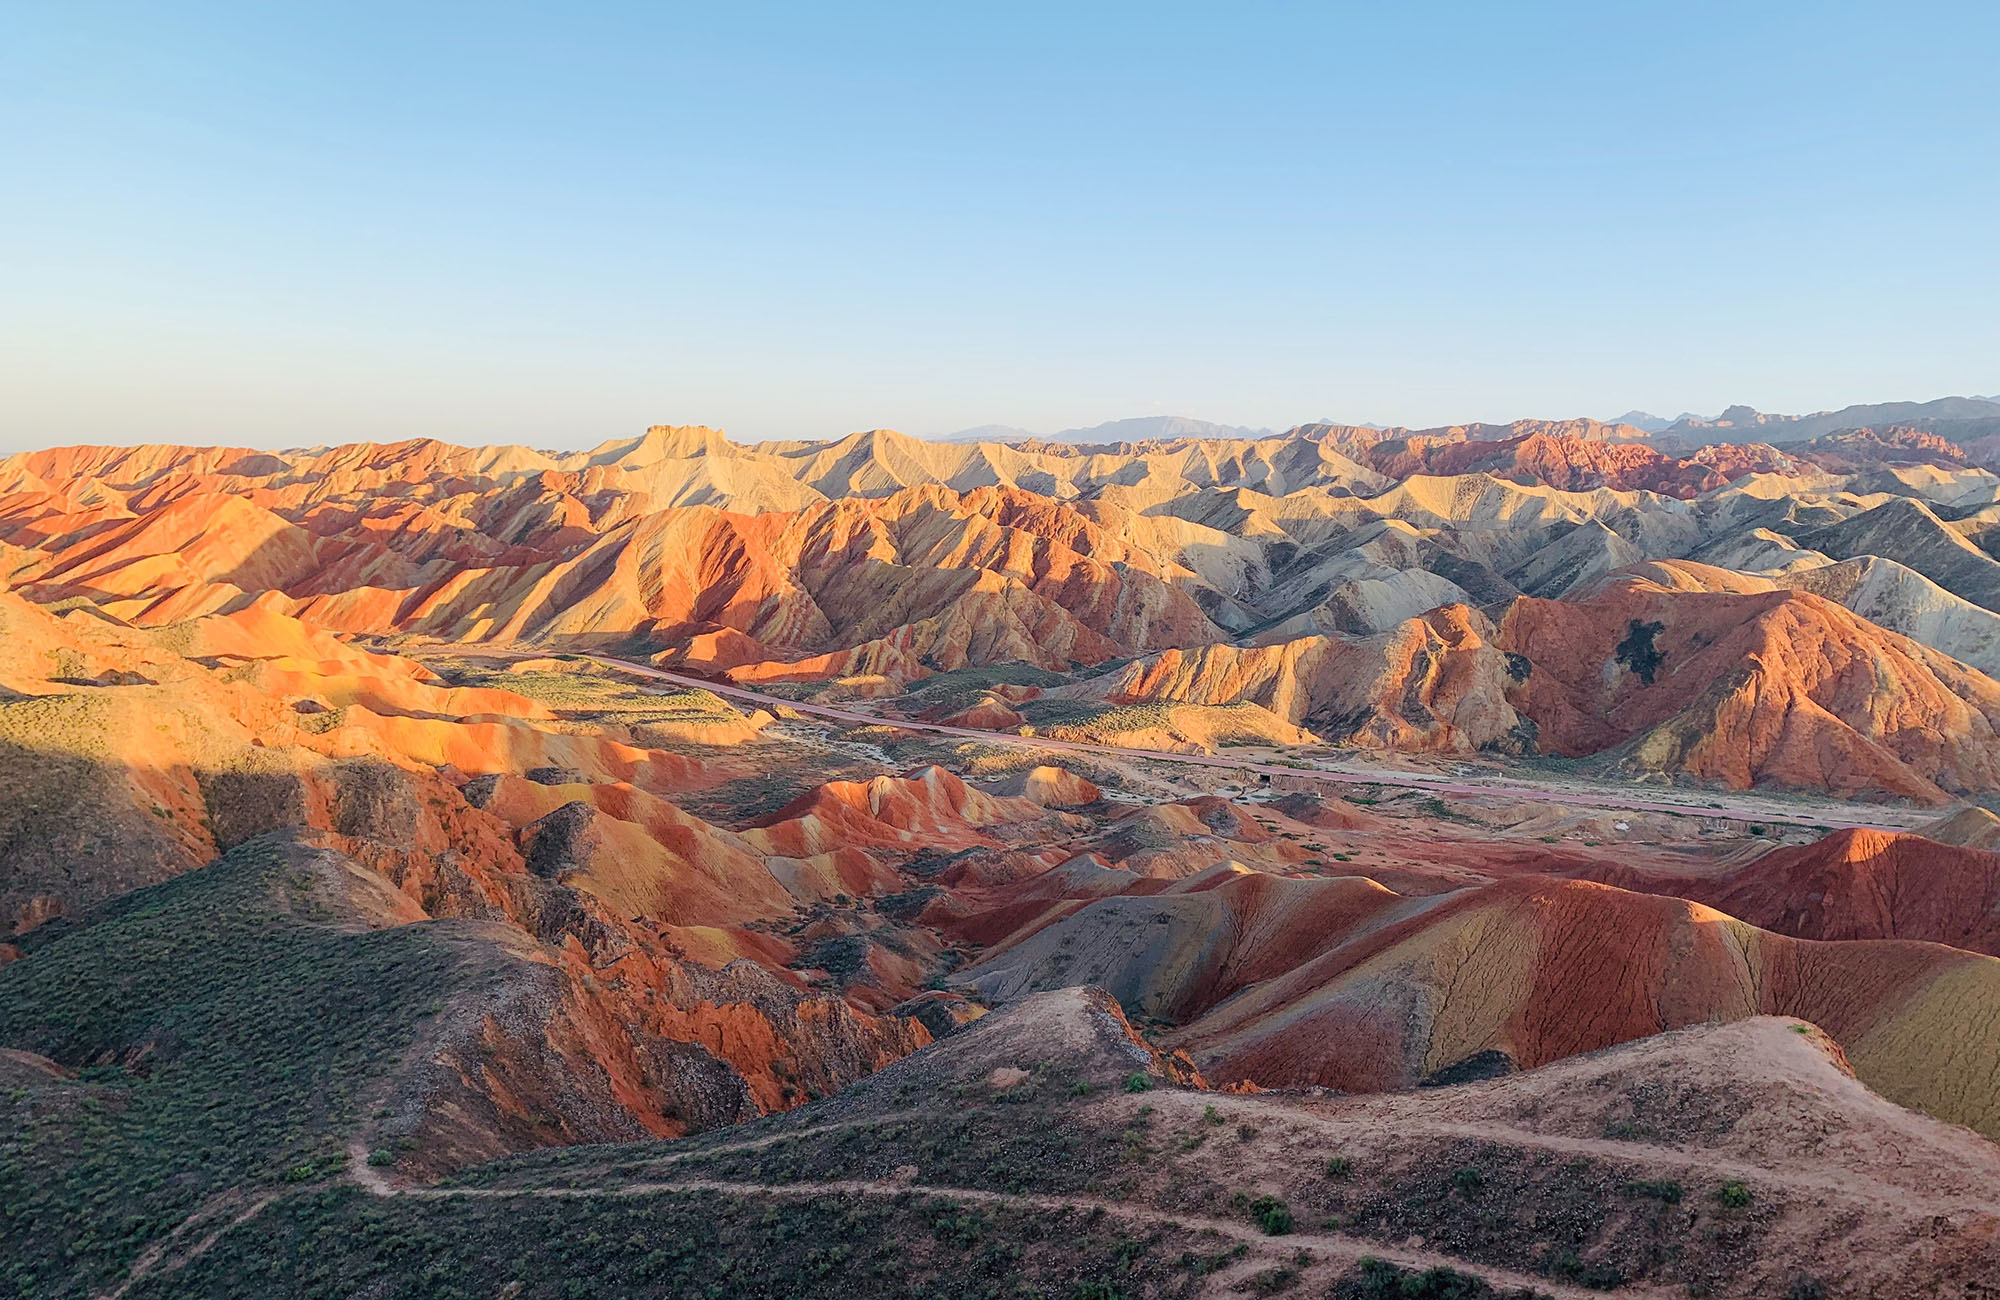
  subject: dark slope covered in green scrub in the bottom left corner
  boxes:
[0,846,460,1298]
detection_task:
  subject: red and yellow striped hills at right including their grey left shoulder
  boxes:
[966,868,2000,1134]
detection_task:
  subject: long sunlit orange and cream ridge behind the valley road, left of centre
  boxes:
[8,476,1218,680]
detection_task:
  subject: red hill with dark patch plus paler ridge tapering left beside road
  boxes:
[1072,576,2000,802]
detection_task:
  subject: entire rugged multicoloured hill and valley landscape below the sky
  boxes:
[11,422,2000,1300]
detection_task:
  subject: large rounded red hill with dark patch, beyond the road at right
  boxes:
[1496,578,2000,802]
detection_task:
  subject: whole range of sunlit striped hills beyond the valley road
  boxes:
[11,420,2000,800]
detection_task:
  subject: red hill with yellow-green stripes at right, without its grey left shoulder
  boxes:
[1152,878,2000,1134]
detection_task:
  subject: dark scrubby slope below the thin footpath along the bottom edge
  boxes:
[130,1186,1216,1300]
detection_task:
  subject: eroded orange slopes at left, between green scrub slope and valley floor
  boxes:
[0,592,944,1168]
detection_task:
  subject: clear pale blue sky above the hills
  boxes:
[0,0,2000,452]
